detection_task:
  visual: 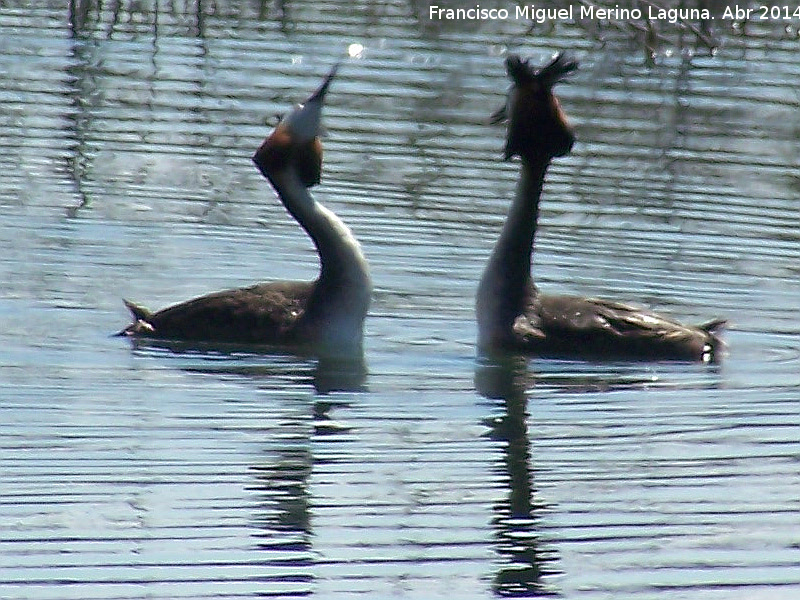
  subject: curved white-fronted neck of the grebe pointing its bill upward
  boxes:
[269,169,370,289]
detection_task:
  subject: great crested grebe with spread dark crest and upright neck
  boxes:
[476,54,725,362]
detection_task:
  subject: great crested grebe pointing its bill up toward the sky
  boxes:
[120,67,372,354]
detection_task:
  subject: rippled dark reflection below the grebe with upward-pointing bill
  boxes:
[126,338,367,596]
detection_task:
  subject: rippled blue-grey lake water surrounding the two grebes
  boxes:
[0,0,800,600]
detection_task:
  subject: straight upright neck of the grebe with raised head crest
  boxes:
[477,159,550,343]
